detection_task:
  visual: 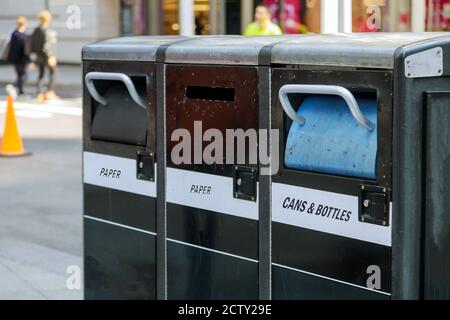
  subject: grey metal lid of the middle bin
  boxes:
[166,35,292,65]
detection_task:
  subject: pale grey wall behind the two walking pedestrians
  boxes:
[0,0,120,63]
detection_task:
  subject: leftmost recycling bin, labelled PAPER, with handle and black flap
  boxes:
[82,37,184,299]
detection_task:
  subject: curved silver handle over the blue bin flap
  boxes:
[279,84,375,132]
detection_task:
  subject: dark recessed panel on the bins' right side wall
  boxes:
[424,92,450,300]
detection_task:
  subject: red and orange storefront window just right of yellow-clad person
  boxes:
[264,0,320,34]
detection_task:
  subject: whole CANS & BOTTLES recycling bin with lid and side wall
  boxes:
[271,33,450,299]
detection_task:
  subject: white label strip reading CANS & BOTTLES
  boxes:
[272,183,392,247]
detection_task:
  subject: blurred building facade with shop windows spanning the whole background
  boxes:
[0,0,450,63]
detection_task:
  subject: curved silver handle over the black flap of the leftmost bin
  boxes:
[85,72,147,109]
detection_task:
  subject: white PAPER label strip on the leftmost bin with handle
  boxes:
[83,152,156,197]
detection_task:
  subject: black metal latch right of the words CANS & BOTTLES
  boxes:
[359,186,391,227]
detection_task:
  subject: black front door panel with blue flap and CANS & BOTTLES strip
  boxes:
[271,66,393,299]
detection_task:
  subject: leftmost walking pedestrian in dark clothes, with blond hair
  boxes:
[8,17,29,95]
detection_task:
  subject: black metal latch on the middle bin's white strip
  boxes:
[233,166,258,202]
